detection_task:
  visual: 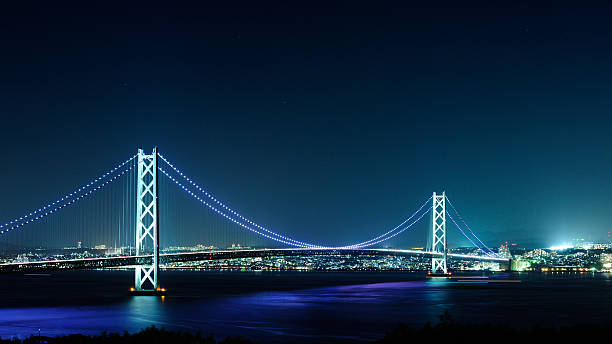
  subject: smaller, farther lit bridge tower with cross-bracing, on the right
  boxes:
[431,192,448,275]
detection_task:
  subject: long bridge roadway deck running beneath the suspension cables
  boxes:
[0,248,510,273]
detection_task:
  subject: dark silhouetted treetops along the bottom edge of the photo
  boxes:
[0,313,612,344]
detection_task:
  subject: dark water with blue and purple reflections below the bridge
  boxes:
[0,271,612,342]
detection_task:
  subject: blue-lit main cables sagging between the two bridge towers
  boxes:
[158,163,431,249]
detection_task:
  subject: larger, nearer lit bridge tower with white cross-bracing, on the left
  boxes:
[131,147,165,294]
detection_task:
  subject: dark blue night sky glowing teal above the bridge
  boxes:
[0,1,612,249]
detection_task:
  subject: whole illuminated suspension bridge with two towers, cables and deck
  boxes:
[0,148,509,293]
